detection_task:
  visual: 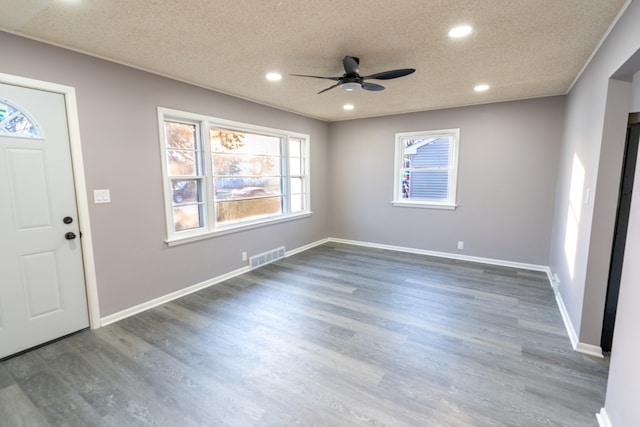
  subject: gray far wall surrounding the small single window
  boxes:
[330,97,564,266]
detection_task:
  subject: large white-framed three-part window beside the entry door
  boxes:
[158,107,311,245]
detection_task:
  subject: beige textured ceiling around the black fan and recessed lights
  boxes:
[0,0,625,121]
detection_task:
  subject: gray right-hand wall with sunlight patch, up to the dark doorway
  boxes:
[549,2,640,346]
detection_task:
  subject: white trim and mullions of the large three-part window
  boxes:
[158,107,312,246]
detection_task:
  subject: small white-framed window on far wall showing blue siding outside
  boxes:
[393,129,460,209]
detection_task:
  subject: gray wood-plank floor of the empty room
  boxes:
[0,243,608,427]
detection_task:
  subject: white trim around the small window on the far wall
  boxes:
[391,128,460,210]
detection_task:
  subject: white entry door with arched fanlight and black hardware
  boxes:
[0,84,89,358]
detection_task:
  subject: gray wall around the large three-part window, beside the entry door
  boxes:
[0,32,329,317]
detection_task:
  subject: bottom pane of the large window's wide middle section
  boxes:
[216,194,282,223]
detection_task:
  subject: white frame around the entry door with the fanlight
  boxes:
[0,73,101,329]
